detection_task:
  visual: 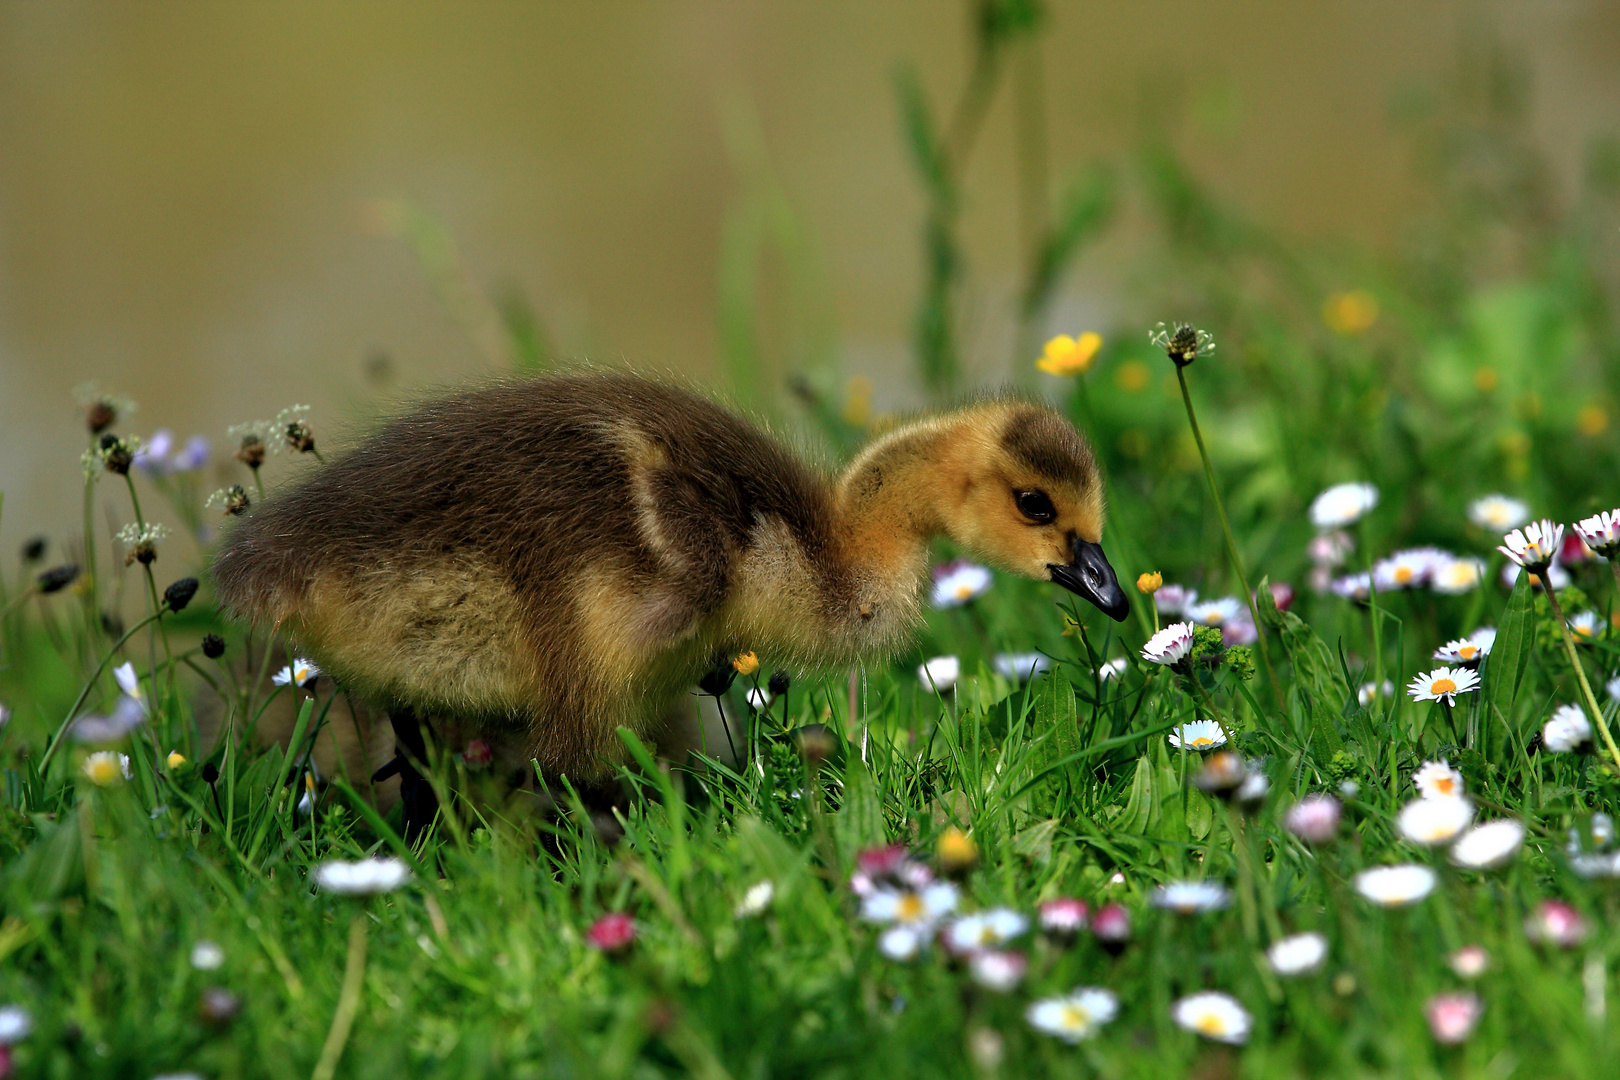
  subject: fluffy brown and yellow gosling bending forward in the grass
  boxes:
[214,374,1128,836]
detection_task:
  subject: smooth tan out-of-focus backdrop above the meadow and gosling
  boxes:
[0,0,1620,557]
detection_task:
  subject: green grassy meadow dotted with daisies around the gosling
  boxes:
[0,3,1620,1080]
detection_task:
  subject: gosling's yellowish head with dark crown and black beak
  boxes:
[944,402,1129,622]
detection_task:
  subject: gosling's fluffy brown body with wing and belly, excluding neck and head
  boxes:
[214,376,836,776]
